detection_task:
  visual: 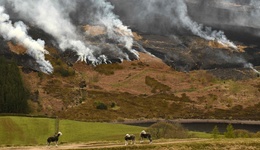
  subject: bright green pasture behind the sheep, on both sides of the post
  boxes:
[0,116,144,146]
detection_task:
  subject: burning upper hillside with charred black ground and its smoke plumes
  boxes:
[0,0,260,74]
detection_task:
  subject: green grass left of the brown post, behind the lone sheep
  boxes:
[0,117,54,145]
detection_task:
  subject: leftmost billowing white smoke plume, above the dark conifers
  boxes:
[0,6,53,74]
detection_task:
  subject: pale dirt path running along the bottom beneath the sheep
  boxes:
[0,139,210,150]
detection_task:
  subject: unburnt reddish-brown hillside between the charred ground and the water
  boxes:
[17,45,260,121]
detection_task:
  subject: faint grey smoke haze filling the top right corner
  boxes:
[186,0,260,36]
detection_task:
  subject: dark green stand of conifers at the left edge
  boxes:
[0,57,29,113]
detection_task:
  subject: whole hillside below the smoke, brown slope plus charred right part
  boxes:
[3,26,260,121]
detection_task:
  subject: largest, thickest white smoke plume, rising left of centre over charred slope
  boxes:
[5,0,138,65]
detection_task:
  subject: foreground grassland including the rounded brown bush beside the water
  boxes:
[0,116,260,150]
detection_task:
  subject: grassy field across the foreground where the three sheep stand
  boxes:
[0,116,260,150]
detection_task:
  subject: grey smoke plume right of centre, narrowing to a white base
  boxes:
[109,0,237,49]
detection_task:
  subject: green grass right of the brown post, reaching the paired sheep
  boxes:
[60,120,144,142]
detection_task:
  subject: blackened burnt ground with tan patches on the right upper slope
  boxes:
[134,34,260,79]
